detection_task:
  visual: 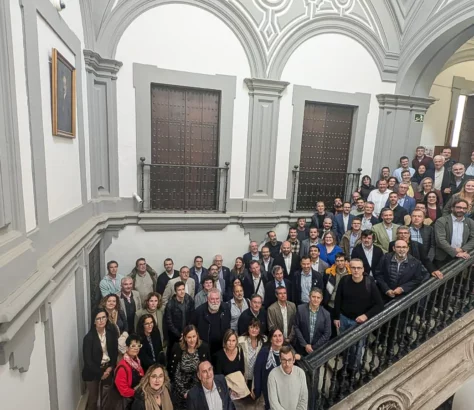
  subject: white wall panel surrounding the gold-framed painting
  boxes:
[37,15,82,220]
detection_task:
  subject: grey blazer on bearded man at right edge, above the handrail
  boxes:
[435,215,474,261]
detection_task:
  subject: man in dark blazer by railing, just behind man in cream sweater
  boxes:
[295,289,331,356]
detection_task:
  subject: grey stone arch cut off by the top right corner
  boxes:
[396,2,474,97]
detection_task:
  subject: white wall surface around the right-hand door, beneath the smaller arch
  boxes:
[274,34,395,198]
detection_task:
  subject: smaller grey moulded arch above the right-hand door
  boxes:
[268,16,398,82]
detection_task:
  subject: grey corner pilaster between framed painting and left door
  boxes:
[84,50,122,198]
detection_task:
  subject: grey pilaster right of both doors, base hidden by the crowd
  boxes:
[372,94,436,182]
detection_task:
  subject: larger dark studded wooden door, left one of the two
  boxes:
[150,84,220,210]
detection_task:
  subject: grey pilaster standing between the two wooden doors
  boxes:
[243,78,289,212]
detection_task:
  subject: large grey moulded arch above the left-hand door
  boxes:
[92,0,266,78]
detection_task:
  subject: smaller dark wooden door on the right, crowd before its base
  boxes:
[296,101,354,210]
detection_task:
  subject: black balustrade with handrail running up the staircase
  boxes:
[300,251,474,410]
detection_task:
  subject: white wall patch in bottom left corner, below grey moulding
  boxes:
[0,323,50,410]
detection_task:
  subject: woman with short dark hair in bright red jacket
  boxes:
[115,335,144,401]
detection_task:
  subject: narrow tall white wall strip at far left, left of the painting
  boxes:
[10,0,36,232]
